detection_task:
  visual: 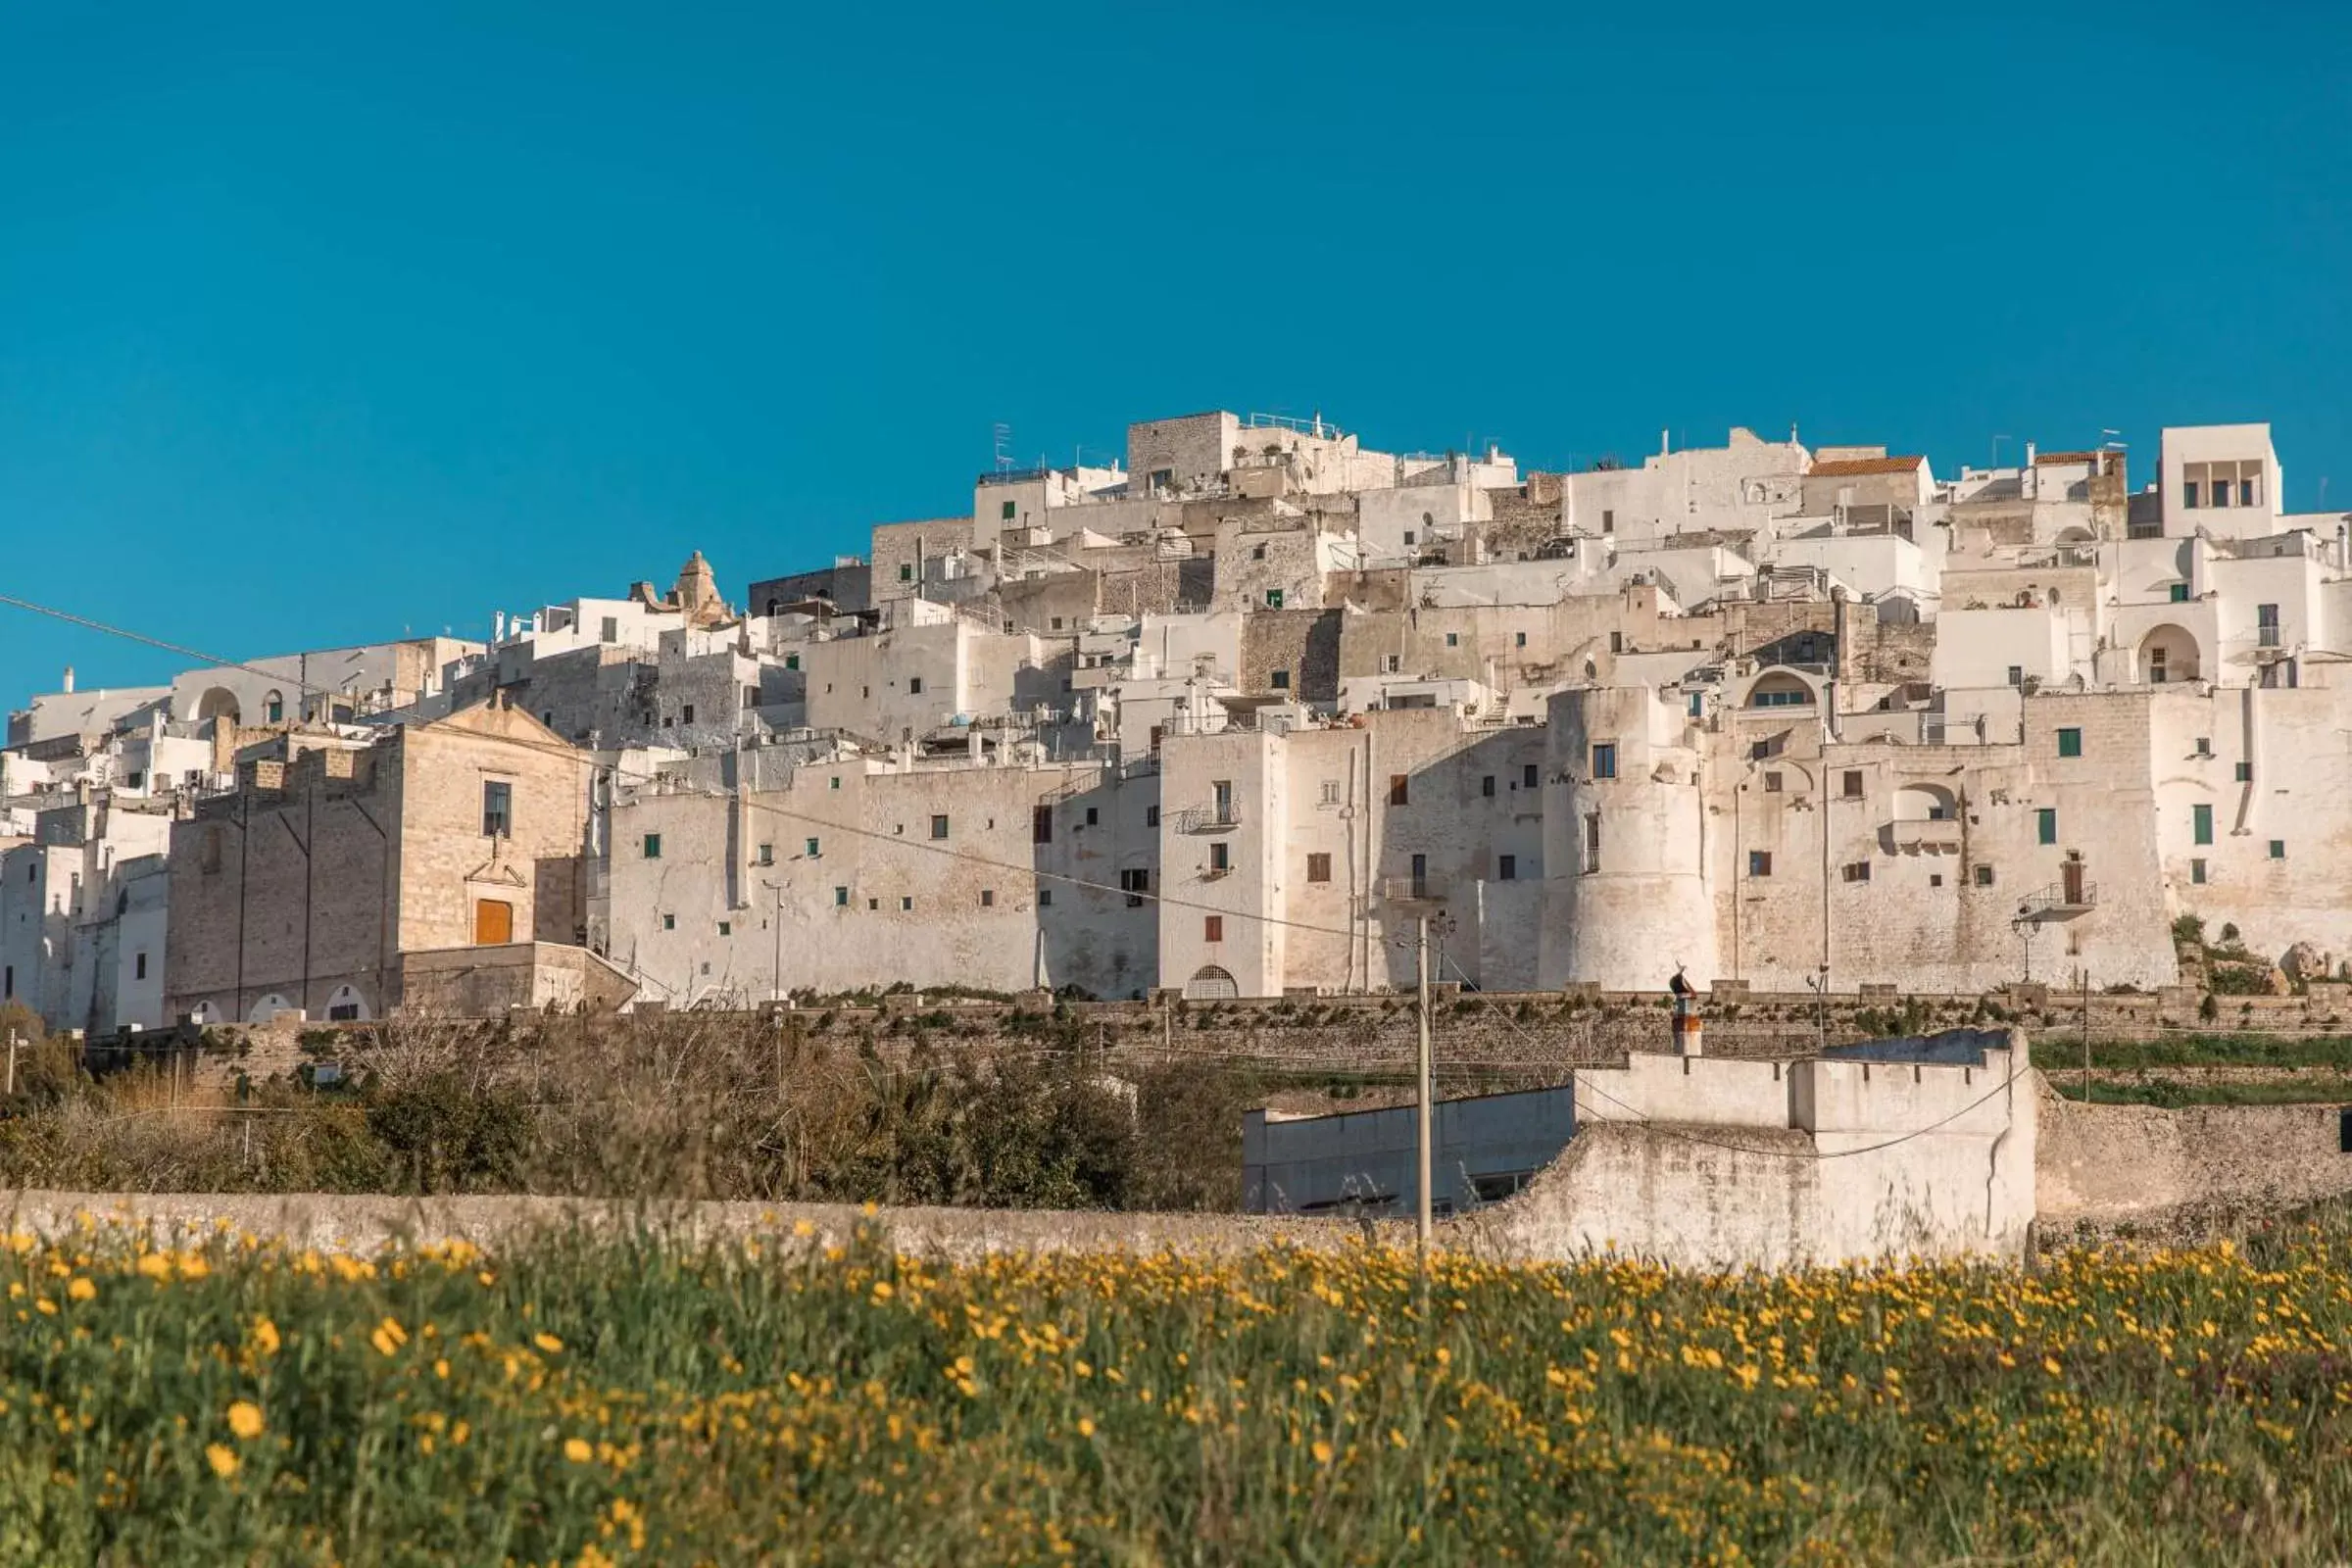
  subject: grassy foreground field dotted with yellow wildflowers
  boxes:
[0,1220,2352,1566]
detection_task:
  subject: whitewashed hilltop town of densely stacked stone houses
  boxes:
[0,414,2352,1034]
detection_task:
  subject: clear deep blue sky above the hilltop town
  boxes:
[0,0,2352,706]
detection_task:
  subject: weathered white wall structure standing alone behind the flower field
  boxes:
[1448,1032,2041,1269]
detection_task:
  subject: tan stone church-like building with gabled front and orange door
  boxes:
[165,703,588,1020]
